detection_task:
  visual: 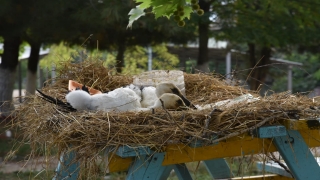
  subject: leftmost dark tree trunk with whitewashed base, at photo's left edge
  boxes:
[0,37,21,116]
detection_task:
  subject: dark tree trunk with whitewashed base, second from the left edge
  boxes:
[26,43,41,95]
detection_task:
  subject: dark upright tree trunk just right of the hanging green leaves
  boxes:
[197,0,211,69]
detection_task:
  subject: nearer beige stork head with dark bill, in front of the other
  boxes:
[151,93,187,110]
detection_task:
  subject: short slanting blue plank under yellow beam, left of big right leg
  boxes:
[203,158,234,179]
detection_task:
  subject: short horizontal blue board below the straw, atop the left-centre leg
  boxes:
[116,146,153,158]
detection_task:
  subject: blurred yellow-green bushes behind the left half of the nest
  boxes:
[40,43,179,74]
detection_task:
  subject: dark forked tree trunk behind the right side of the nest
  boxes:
[248,43,271,90]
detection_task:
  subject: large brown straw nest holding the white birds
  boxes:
[9,61,320,177]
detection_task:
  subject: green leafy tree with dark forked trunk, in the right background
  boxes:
[216,0,319,90]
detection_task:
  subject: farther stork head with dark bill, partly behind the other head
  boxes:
[156,82,197,109]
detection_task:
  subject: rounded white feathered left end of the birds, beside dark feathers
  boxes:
[66,90,91,110]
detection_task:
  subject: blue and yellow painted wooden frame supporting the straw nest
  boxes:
[54,120,320,180]
